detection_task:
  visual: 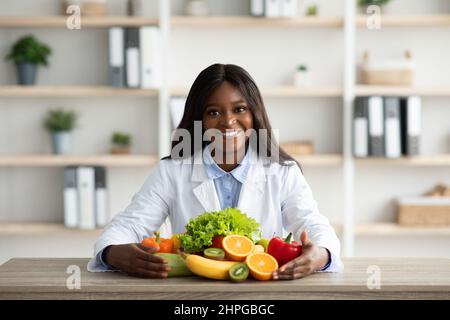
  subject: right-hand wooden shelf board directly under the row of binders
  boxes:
[355,154,450,167]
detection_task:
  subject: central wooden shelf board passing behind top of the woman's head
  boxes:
[170,86,342,98]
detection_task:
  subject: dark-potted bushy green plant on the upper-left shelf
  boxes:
[6,35,51,85]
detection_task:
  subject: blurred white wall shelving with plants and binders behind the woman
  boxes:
[0,0,450,263]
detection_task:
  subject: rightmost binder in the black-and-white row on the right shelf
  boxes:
[400,96,422,156]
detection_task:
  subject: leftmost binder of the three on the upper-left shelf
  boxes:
[109,27,125,87]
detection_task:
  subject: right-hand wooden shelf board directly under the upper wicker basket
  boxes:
[355,85,450,97]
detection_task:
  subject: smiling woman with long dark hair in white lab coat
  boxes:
[88,64,343,280]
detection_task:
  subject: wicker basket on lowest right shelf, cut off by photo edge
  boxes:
[398,197,450,226]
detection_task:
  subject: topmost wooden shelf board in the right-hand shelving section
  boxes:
[356,14,450,28]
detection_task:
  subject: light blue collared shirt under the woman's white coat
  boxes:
[203,147,251,210]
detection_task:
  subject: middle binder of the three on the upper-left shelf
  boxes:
[125,27,140,88]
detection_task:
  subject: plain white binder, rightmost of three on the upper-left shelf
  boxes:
[139,27,161,88]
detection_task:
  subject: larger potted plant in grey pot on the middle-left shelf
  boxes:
[44,109,77,154]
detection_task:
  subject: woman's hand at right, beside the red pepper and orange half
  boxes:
[272,231,330,280]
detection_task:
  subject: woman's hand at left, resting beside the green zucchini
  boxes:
[104,243,170,278]
